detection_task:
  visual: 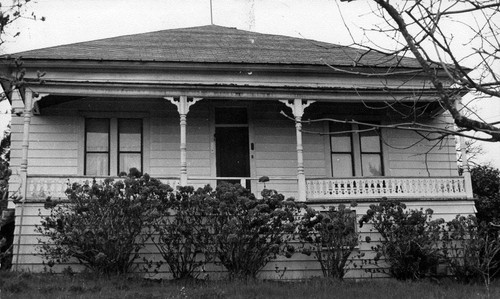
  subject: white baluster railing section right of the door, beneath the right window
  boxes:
[306,177,467,200]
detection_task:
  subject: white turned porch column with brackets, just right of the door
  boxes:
[280,99,315,201]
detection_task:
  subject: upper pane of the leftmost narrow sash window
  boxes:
[85,118,109,152]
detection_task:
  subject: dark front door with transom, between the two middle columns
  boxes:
[215,107,250,188]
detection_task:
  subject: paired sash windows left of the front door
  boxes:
[84,118,143,176]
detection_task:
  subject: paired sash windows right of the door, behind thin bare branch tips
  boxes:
[330,123,384,177]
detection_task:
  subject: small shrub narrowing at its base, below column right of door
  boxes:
[298,204,358,279]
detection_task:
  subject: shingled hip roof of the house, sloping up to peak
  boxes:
[7,25,419,68]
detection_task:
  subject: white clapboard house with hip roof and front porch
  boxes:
[1,25,474,278]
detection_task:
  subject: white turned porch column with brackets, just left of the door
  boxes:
[164,96,202,186]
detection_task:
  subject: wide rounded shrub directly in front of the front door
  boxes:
[206,184,299,279]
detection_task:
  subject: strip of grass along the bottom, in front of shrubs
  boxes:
[0,272,500,299]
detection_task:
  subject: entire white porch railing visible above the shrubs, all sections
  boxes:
[26,175,467,202]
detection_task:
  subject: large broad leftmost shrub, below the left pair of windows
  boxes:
[36,174,172,274]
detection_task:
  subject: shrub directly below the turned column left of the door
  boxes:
[146,186,212,279]
